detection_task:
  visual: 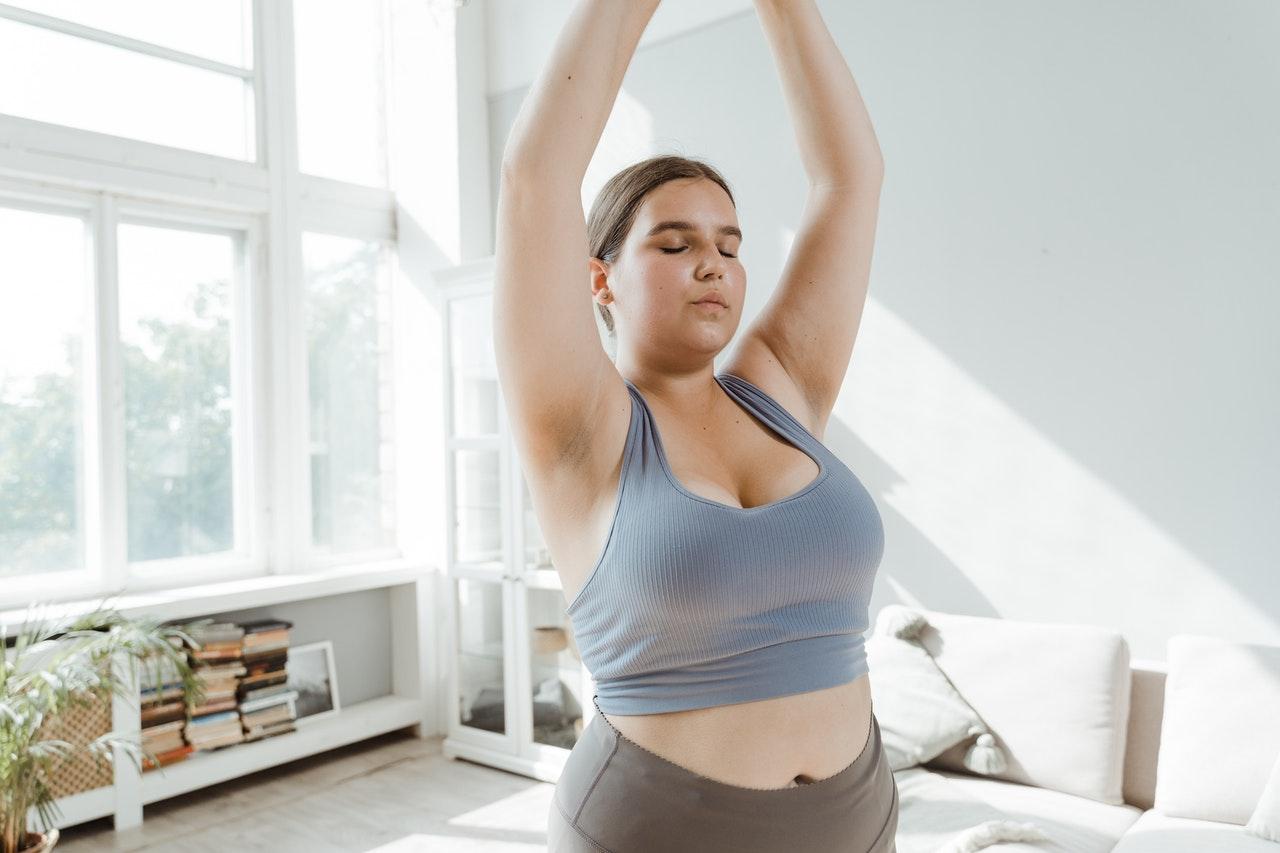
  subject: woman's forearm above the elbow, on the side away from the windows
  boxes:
[755,0,883,186]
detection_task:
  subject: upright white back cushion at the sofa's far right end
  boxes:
[1155,634,1280,819]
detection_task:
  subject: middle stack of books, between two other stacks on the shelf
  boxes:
[186,622,246,751]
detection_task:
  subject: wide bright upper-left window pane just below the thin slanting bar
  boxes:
[0,18,255,160]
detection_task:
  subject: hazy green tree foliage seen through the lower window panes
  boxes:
[0,243,387,578]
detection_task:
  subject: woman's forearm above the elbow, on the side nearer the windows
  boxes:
[503,0,659,186]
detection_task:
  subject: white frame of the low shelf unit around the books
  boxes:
[0,561,439,830]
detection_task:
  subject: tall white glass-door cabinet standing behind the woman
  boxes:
[436,257,595,781]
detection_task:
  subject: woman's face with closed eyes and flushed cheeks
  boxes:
[593,178,746,360]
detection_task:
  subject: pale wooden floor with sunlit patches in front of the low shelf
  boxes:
[55,731,554,853]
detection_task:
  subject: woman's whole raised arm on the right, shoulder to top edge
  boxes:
[733,0,884,427]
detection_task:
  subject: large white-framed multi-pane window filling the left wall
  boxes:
[0,0,398,607]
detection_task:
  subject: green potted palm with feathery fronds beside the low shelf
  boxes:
[0,601,204,853]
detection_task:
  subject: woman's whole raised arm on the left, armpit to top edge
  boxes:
[494,0,658,473]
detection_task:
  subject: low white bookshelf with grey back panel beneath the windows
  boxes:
[0,561,439,830]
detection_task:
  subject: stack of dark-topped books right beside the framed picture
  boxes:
[239,619,298,742]
